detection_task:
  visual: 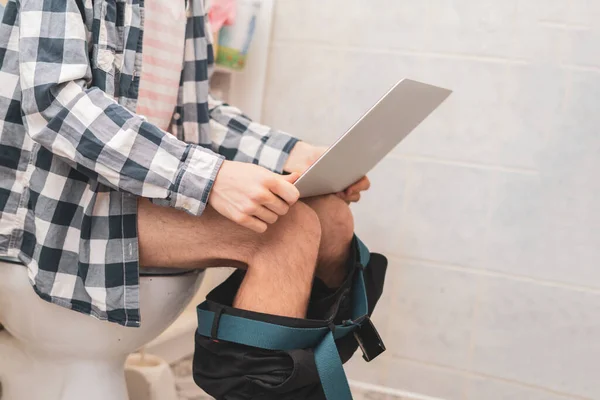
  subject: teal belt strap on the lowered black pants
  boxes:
[197,237,370,400]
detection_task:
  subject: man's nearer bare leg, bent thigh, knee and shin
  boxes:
[138,200,321,318]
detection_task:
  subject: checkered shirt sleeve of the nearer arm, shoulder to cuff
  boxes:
[19,0,223,215]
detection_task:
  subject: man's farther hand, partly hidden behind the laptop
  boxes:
[283,142,371,203]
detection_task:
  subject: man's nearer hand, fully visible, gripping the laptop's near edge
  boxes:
[208,161,300,233]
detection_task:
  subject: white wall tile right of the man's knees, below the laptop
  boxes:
[394,162,498,265]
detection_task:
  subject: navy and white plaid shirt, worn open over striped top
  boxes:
[0,0,296,326]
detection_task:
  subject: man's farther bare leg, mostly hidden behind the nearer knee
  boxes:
[304,195,354,288]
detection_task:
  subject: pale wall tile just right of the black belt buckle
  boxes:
[387,261,481,369]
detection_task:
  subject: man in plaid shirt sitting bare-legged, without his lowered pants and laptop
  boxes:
[0,0,369,326]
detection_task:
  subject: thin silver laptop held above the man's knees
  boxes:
[295,79,452,197]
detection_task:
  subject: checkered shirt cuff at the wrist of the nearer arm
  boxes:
[169,144,225,216]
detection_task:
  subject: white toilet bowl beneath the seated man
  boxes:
[0,262,203,400]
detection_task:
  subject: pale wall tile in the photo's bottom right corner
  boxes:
[471,278,600,398]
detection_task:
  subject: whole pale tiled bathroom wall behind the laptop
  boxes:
[263,0,600,400]
